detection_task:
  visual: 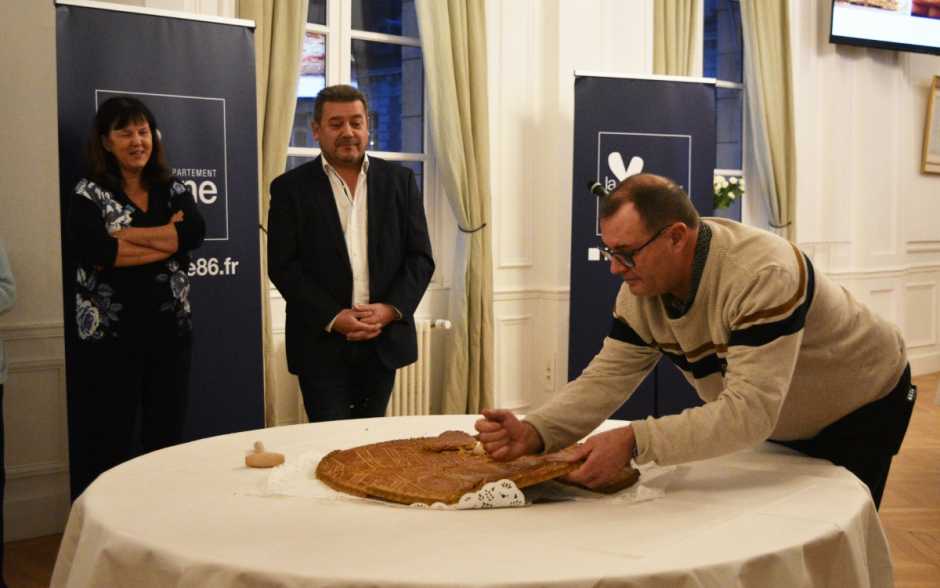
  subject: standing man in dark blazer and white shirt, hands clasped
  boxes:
[268,86,434,422]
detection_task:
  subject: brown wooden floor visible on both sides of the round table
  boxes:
[5,373,940,588]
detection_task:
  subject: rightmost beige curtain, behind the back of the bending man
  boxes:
[741,0,796,240]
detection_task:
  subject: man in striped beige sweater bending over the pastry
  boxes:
[476,174,916,505]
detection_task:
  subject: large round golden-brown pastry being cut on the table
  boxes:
[316,431,638,504]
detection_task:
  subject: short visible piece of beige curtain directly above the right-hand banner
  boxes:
[653,0,703,76]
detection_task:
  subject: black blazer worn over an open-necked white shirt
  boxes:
[268,157,434,375]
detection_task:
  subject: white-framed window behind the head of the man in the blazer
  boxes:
[287,0,427,191]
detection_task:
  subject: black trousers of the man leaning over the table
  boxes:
[771,365,917,508]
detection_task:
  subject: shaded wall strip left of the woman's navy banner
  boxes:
[0,0,68,539]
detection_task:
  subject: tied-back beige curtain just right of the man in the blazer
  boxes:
[416,0,493,414]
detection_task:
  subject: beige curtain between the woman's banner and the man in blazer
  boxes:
[238,0,307,426]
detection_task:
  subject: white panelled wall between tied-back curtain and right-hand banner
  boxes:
[486,0,653,410]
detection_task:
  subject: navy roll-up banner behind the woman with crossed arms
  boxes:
[56,2,264,446]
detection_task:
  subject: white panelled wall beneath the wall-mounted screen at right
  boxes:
[791,2,940,374]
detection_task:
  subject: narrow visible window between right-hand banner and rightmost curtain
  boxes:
[702,0,744,215]
